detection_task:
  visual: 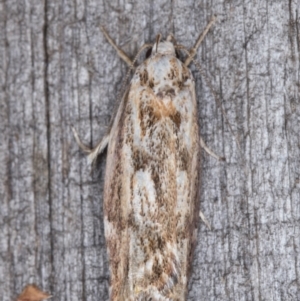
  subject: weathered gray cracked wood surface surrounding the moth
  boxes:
[0,0,300,301]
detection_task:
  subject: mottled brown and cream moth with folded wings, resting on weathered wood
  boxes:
[73,18,223,301]
